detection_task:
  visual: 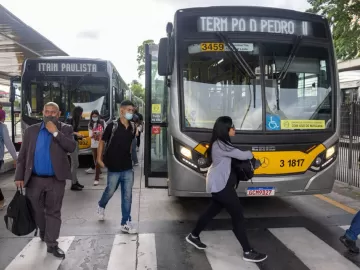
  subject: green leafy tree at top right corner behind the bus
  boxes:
[307,0,360,60]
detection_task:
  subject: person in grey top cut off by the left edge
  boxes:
[0,109,17,210]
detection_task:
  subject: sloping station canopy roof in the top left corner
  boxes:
[0,5,68,85]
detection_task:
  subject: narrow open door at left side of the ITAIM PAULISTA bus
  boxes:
[9,76,22,152]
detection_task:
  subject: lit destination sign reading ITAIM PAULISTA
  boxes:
[37,62,97,73]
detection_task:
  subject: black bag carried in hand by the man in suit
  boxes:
[4,188,37,236]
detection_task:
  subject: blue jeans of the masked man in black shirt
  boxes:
[99,170,134,225]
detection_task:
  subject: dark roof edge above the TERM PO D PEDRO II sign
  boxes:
[175,6,326,22]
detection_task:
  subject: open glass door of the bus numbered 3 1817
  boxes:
[144,44,168,188]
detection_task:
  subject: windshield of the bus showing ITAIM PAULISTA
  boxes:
[23,76,110,120]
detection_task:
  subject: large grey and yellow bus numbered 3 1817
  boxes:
[145,6,340,197]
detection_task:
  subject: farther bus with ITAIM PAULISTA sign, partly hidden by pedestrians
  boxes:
[10,57,128,155]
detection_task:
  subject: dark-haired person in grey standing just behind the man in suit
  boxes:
[66,106,84,191]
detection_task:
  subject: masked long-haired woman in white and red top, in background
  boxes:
[89,110,106,186]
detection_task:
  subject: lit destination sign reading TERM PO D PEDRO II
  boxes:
[197,16,311,36]
